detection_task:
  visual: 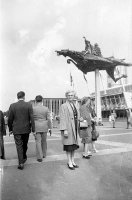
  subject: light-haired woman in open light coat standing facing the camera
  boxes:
[60,91,80,170]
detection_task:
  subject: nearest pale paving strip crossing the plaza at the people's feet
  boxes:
[0,148,132,169]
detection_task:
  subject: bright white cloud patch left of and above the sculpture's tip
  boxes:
[28,18,65,66]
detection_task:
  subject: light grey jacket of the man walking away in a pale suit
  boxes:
[33,104,52,132]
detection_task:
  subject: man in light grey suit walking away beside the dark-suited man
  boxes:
[33,95,52,162]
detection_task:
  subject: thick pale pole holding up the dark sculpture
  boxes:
[95,69,102,120]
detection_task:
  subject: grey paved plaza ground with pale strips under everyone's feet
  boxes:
[0,120,132,200]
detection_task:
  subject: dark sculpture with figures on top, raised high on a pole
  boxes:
[56,37,132,82]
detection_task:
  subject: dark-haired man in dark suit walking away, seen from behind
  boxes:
[8,91,35,170]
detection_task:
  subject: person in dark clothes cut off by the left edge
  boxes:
[0,110,6,159]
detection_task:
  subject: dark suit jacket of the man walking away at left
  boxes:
[8,100,35,135]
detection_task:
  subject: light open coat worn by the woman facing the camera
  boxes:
[60,102,79,145]
